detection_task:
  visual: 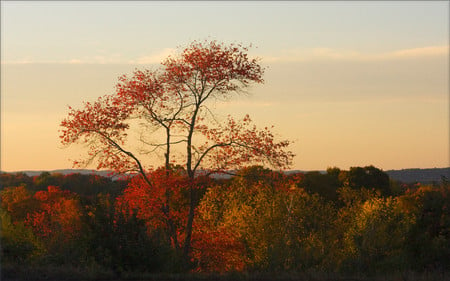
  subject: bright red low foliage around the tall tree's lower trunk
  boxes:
[116,169,245,272]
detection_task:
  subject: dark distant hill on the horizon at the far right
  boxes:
[385,167,450,184]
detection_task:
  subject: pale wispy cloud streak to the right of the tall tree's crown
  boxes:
[261,46,449,62]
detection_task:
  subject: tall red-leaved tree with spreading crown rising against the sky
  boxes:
[60,41,293,264]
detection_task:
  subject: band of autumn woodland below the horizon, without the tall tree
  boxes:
[0,166,450,280]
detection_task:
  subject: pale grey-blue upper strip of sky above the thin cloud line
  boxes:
[2,1,448,62]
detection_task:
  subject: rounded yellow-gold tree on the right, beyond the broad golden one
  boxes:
[341,197,414,272]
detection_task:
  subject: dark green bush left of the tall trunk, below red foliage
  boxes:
[86,193,175,275]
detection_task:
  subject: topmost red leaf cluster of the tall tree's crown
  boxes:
[162,41,264,95]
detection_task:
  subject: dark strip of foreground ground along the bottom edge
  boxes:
[0,266,450,281]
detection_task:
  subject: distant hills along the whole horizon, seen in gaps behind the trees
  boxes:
[1,167,450,184]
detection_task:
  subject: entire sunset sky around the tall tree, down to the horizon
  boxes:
[0,1,450,171]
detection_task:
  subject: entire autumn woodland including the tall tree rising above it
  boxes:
[0,41,450,281]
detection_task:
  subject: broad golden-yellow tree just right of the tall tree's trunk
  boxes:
[194,167,334,271]
